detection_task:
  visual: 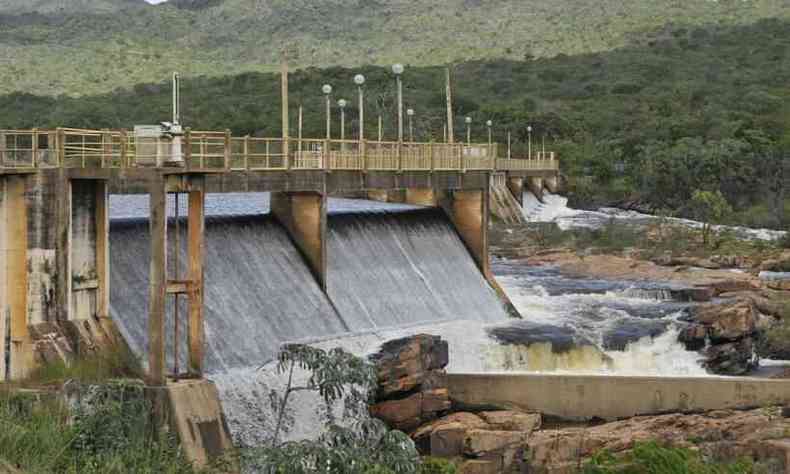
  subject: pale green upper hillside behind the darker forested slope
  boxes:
[0,0,790,95]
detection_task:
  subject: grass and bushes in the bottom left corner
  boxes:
[0,385,193,474]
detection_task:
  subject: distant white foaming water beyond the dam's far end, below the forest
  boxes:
[523,192,786,240]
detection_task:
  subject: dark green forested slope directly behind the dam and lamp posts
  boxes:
[0,20,790,230]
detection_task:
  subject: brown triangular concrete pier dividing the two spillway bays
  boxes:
[271,192,327,290]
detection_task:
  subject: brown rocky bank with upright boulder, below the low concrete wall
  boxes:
[370,336,790,474]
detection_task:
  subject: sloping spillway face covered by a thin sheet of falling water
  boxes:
[110,193,507,372]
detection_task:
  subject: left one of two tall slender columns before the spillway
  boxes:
[148,178,167,386]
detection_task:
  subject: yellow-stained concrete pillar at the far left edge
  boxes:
[0,176,34,380]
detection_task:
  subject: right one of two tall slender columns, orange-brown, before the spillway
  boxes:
[187,191,206,376]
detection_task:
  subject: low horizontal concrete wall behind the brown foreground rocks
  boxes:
[448,374,790,420]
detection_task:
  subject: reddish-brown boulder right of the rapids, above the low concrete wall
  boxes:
[693,299,757,343]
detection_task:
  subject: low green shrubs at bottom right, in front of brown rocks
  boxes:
[583,441,765,474]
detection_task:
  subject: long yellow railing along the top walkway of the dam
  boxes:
[0,128,558,171]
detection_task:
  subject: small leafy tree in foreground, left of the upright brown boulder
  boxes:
[244,345,419,474]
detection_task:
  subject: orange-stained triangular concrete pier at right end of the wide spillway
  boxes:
[442,189,493,281]
